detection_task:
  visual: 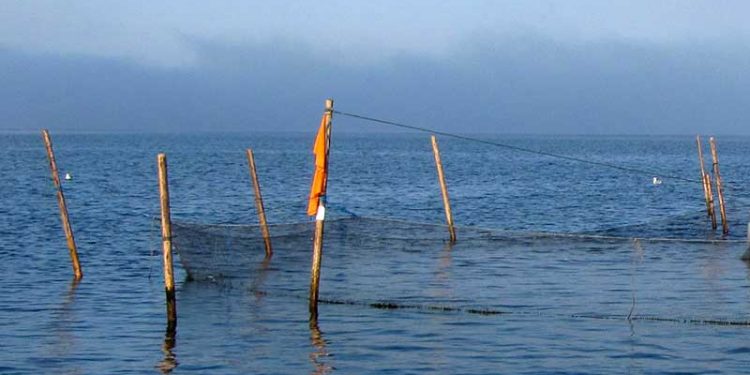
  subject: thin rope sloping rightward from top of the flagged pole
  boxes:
[333,110,703,183]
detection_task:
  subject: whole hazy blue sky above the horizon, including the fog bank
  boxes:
[0,0,750,135]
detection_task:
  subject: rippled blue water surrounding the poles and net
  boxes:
[0,131,750,374]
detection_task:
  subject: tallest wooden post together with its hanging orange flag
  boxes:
[307,99,333,320]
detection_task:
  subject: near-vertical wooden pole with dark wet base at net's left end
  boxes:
[156,154,177,332]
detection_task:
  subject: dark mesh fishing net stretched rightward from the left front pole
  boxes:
[173,217,750,325]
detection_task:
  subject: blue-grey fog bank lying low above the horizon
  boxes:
[0,33,750,135]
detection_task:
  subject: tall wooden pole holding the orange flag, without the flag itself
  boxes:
[309,99,333,320]
